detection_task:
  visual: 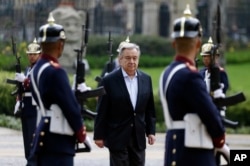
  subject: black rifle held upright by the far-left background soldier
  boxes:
[6,36,23,116]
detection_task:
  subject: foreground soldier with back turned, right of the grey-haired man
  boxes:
[159,6,225,166]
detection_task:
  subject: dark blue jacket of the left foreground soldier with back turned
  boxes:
[32,54,83,155]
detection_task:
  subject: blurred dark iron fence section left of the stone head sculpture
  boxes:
[0,0,59,41]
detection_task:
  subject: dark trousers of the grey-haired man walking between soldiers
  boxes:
[109,136,145,166]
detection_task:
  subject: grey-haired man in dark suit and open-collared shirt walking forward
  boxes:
[94,43,155,166]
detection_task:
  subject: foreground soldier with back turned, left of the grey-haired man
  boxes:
[31,13,86,166]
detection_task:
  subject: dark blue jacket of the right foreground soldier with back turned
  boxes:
[163,56,225,166]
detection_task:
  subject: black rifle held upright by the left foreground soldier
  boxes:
[74,13,105,152]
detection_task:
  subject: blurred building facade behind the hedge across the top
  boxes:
[0,0,250,41]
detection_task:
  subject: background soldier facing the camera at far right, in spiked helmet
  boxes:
[200,37,229,94]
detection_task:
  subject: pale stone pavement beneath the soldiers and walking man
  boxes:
[0,127,250,166]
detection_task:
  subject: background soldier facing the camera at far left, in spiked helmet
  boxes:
[14,39,41,165]
